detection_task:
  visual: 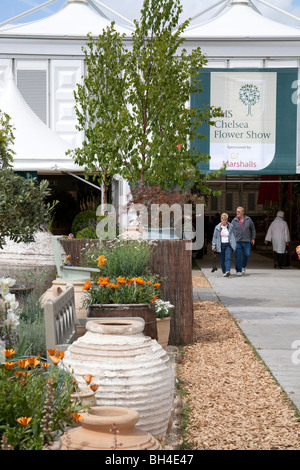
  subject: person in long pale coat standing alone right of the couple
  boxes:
[265,211,290,269]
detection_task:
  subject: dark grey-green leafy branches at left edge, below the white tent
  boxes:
[0,168,55,248]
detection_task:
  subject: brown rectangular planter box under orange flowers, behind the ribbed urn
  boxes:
[88,304,157,340]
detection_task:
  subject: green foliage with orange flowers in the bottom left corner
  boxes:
[0,356,78,450]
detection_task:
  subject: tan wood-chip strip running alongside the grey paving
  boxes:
[178,278,300,450]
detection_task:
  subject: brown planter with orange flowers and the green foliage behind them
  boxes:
[83,238,160,339]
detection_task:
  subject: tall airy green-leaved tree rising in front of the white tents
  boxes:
[70,0,221,193]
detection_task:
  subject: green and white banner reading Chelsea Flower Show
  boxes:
[192,69,297,174]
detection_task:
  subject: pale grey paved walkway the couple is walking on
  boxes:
[194,251,300,410]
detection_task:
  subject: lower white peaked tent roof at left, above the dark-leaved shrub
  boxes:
[0,73,79,171]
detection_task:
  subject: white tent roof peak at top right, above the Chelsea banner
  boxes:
[183,0,300,40]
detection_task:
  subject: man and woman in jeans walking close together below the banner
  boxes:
[212,207,256,277]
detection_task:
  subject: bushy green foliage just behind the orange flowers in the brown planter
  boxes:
[82,239,154,278]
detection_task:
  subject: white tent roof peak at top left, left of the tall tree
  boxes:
[0,0,131,38]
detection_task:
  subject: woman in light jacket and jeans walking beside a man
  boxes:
[212,213,236,277]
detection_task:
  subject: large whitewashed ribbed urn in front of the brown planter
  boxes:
[63,318,174,439]
